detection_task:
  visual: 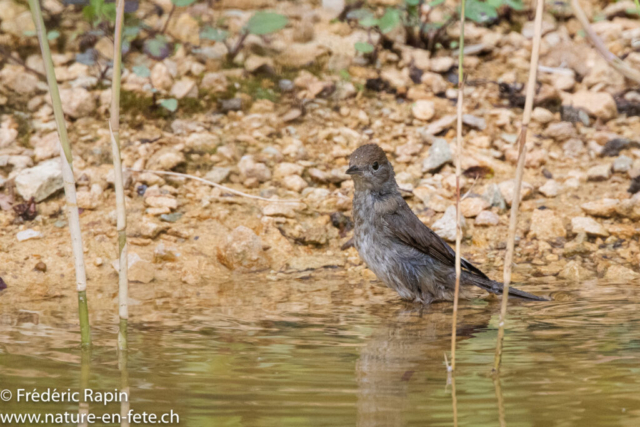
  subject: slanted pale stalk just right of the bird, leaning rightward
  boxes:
[493,0,544,372]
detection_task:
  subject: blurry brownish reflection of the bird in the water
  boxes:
[356,304,492,427]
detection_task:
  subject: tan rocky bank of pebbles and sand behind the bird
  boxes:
[0,0,640,304]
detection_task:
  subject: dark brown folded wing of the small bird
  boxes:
[382,201,488,279]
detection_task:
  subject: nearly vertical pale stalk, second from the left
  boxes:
[109,0,129,350]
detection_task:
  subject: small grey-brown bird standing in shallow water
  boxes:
[347,144,547,304]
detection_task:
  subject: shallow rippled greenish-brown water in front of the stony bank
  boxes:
[0,275,640,427]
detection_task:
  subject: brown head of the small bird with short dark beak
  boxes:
[347,144,397,192]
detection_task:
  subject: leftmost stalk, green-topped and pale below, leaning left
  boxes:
[29,0,91,347]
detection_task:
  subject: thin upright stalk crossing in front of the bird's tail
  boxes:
[451,0,466,371]
